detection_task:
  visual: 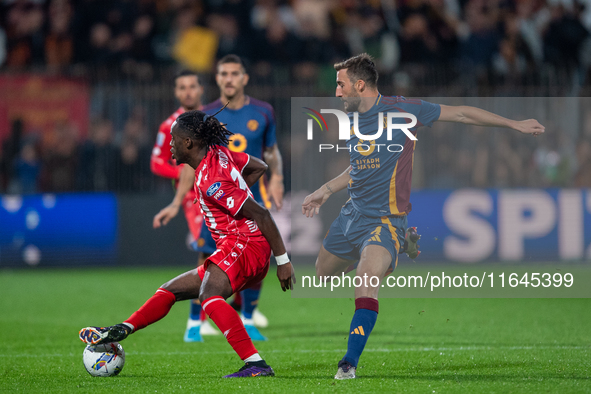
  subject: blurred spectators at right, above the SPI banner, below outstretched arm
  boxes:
[413,110,591,189]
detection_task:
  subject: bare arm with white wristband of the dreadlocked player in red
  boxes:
[240,197,296,291]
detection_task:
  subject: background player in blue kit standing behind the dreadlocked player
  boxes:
[185,55,284,341]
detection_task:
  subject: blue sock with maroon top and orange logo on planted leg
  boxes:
[343,298,378,367]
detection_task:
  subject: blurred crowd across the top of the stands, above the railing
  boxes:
[0,0,591,84]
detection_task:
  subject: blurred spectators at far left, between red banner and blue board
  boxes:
[0,107,157,194]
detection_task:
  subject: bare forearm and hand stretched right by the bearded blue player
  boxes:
[438,105,545,136]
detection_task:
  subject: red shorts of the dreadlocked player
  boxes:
[197,238,271,293]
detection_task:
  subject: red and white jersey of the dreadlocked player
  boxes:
[194,146,265,245]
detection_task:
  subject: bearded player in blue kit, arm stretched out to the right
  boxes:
[302,54,544,379]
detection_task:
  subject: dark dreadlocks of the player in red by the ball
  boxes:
[176,101,233,151]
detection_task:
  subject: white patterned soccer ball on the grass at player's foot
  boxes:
[82,342,125,377]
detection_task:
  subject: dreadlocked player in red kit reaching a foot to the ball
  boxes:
[79,111,295,377]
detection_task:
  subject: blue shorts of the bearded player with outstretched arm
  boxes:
[323,201,408,267]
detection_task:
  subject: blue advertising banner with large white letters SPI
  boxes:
[408,189,591,263]
